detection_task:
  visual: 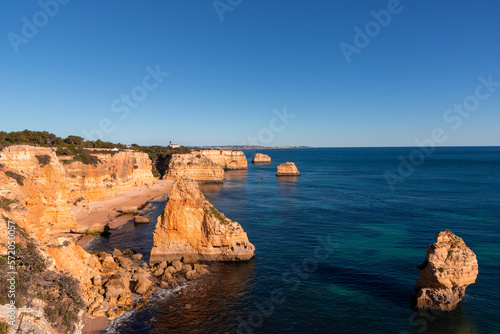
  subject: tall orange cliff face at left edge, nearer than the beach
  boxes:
[0,145,78,244]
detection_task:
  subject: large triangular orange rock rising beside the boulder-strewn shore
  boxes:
[150,178,255,263]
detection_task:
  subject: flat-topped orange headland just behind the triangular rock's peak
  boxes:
[163,153,224,183]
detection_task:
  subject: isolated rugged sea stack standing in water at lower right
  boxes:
[413,230,478,311]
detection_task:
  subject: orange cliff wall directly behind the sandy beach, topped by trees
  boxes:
[64,151,155,202]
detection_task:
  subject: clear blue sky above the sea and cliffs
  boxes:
[0,0,500,147]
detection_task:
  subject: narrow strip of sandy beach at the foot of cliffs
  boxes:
[71,180,174,247]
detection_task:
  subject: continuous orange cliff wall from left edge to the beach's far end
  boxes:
[0,145,155,243]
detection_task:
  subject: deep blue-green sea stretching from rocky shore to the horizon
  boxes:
[89,147,500,333]
